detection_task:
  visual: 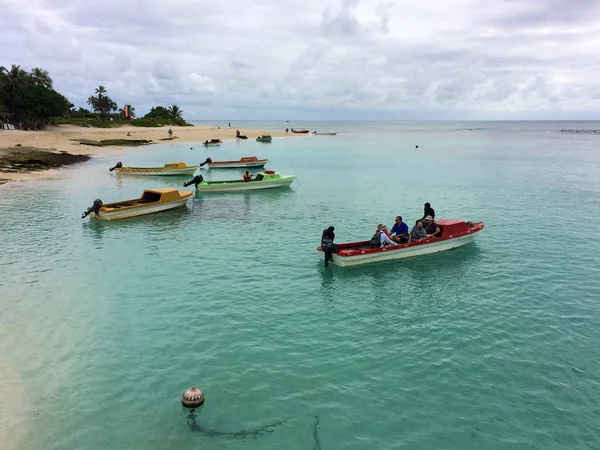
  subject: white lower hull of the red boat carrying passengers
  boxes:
[320,233,477,267]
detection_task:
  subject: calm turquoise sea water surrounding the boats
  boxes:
[0,123,600,450]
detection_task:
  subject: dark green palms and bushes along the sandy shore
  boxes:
[0,64,191,129]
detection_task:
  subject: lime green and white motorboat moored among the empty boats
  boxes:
[184,170,296,192]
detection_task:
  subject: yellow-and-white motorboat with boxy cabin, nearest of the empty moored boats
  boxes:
[81,188,192,220]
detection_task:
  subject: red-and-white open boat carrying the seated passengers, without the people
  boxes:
[317,219,484,267]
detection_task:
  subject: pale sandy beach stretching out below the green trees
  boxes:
[0,125,295,187]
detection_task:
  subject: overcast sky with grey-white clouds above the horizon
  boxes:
[0,0,600,120]
